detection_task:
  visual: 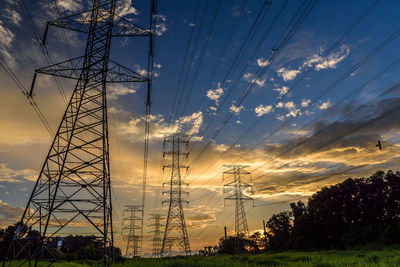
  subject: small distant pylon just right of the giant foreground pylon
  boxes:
[122,205,142,258]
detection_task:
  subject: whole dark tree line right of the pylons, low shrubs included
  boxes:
[200,171,400,255]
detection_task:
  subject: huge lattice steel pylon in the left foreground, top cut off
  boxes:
[3,0,151,266]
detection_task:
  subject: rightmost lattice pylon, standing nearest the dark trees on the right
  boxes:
[222,165,253,252]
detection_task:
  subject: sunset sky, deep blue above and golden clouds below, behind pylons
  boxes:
[0,0,400,258]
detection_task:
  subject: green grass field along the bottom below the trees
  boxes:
[8,246,400,267]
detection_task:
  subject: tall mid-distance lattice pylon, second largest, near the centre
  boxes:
[161,134,191,256]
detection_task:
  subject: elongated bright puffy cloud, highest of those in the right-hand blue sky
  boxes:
[303,45,350,71]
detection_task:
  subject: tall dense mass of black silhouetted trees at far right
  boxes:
[282,171,400,249]
